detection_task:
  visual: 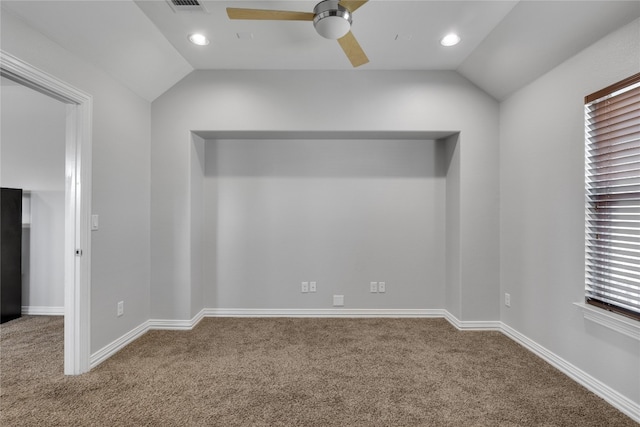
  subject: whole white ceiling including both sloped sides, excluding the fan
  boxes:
[0,0,640,101]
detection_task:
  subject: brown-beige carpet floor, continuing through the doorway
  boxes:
[0,316,638,427]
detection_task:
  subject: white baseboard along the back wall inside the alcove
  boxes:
[203,308,445,318]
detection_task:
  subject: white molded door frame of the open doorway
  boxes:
[0,50,93,375]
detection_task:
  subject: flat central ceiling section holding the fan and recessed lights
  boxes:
[137,0,517,70]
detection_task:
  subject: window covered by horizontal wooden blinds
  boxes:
[585,73,640,320]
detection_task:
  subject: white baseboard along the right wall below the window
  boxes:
[502,323,640,423]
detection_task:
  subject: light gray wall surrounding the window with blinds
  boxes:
[500,20,640,403]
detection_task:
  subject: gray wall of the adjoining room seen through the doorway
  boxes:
[0,82,66,309]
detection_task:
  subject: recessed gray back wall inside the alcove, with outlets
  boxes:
[204,139,445,309]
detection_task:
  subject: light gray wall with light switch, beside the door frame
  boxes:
[0,11,150,352]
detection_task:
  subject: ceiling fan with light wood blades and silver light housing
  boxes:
[227,0,369,67]
